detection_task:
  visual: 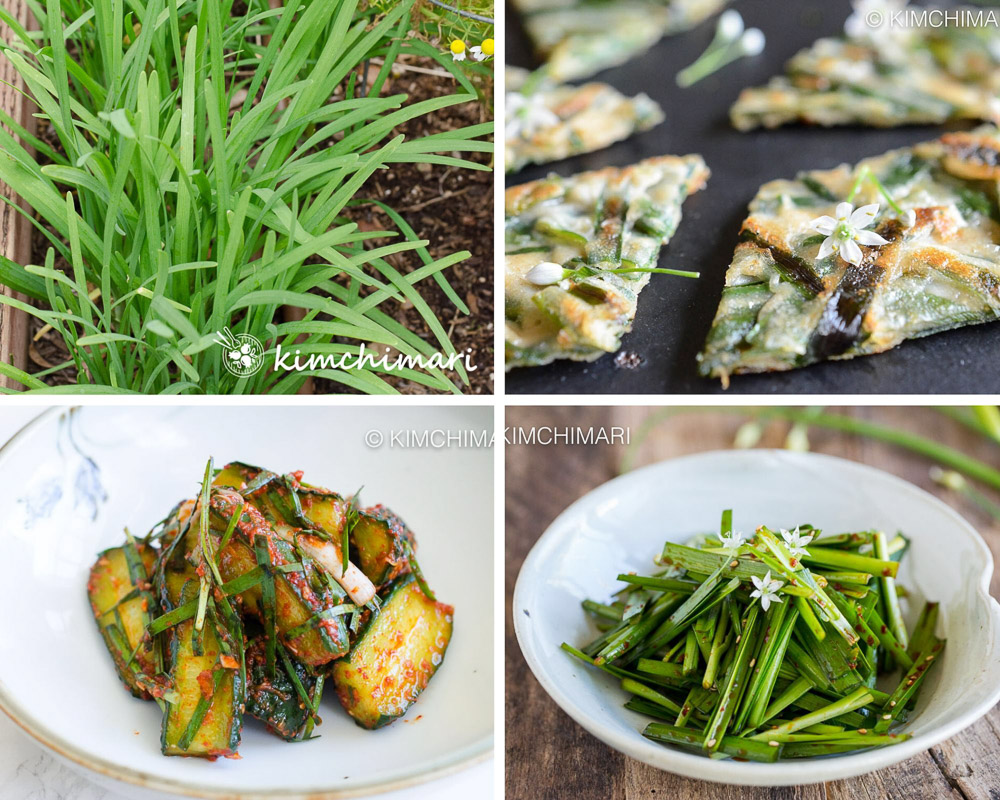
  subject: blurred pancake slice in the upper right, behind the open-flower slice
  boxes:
[730,18,1000,131]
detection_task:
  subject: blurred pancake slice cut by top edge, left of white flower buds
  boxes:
[514,0,726,81]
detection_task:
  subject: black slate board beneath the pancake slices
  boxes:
[506,0,1000,394]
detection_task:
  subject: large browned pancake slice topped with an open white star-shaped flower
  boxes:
[698,126,1000,383]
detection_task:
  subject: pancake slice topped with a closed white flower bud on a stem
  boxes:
[504,155,708,369]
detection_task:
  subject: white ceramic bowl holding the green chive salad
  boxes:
[513,450,1000,786]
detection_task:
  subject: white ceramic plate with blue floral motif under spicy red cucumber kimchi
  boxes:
[0,406,493,798]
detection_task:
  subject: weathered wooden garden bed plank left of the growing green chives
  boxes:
[0,0,34,388]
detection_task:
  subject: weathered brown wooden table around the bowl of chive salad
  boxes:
[505,407,1000,800]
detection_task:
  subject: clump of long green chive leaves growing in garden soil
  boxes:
[0,0,493,394]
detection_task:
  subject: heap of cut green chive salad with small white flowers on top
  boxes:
[562,511,945,762]
